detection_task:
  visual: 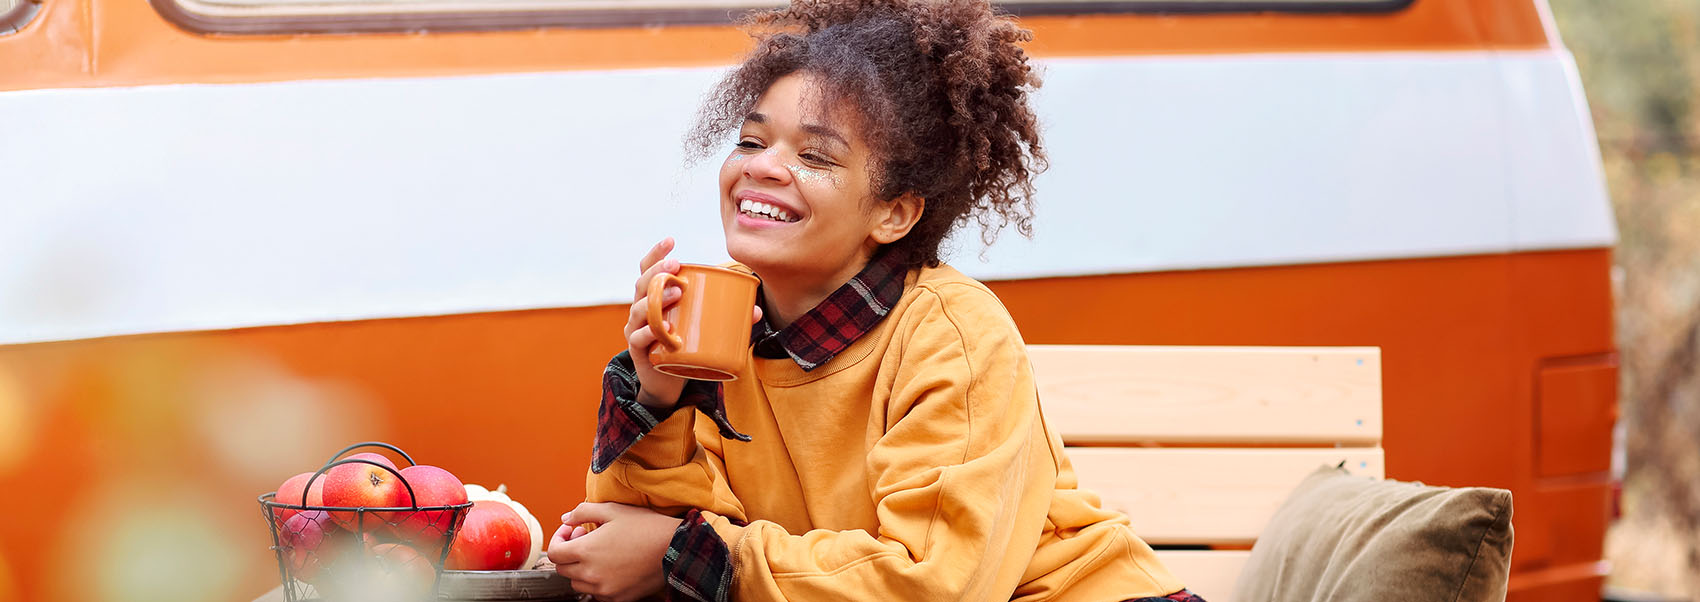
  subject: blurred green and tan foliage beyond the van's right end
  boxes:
[1549,0,1700,599]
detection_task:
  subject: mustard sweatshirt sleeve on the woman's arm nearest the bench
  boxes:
[702,286,1056,600]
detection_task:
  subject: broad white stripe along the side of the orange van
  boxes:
[0,49,1615,344]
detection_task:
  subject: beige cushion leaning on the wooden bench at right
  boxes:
[1234,466,1511,602]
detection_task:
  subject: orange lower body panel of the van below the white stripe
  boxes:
[0,250,1612,600]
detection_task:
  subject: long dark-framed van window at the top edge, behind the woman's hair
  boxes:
[153,0,1416,34]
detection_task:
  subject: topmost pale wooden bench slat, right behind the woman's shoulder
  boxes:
[1027,345,1382,446]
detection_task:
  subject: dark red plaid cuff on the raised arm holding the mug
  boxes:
[590,350,750,473]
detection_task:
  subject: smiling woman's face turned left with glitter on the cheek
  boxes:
[721,73,887,286]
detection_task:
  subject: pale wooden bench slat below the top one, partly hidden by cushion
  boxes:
[1068,447,1386,544]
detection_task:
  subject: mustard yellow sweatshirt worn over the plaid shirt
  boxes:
[587,267,1182,602]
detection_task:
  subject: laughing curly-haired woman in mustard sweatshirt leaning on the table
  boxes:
[549,0,1195,600]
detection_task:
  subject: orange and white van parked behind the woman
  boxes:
[0,0,1617,602]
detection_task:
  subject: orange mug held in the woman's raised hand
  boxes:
[649,264,762,381]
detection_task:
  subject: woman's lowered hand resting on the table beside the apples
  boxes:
[549,502,682,602]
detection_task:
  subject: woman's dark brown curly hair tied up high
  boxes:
[685,0,1047,267]
